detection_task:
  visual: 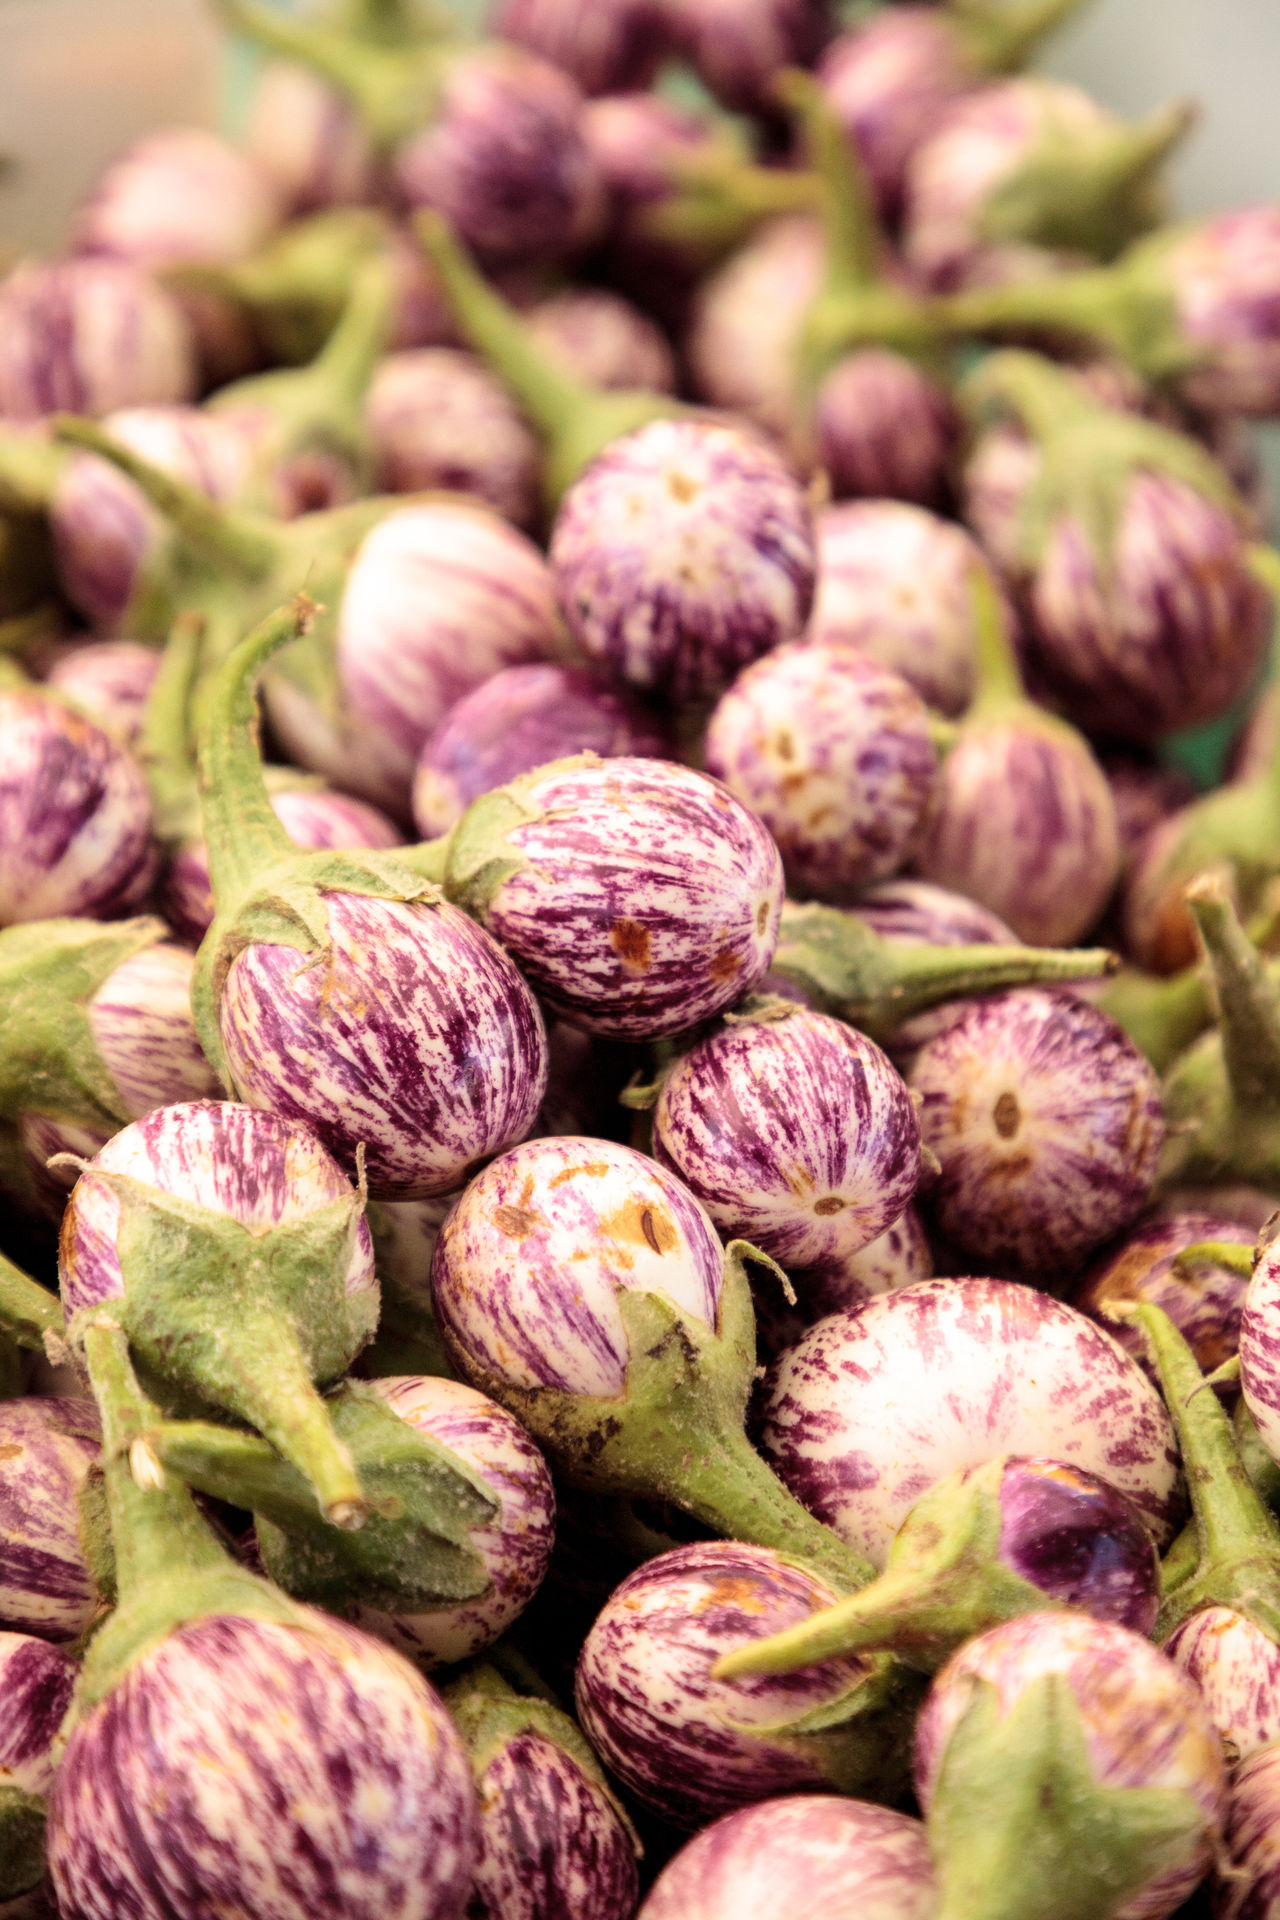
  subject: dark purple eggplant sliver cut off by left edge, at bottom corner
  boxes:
[0,1634,77,1903]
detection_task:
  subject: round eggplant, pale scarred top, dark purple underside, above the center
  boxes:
[551,420,814,703]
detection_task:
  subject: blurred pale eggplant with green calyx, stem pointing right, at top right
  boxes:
[902,75,1196,290]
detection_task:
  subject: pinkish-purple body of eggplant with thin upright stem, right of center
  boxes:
[915,708,1121,947]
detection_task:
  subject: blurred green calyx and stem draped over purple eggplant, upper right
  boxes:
[960,349,1245,582]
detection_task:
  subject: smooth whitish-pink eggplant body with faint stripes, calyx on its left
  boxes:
[338,501,558,787]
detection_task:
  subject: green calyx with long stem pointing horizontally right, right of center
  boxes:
[773,900,1117,1044]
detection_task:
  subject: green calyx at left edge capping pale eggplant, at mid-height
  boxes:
[0,916,169,1133]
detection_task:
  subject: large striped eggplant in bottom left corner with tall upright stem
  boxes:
[48,1313,476,1920]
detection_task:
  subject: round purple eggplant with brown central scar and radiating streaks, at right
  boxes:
[908,987,1165,1279]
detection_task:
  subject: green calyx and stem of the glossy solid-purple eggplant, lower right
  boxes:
[716,1459,1054,1680]
